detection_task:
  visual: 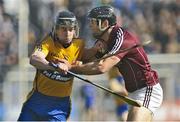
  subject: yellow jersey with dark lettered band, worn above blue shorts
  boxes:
[30,35,84,97]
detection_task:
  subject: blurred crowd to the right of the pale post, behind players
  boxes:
[26,0,180,54]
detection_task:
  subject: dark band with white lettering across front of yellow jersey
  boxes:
[42,70,73,82]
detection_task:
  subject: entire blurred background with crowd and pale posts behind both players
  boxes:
[0,0,180,121]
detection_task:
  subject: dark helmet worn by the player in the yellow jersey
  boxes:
[55,10,79,37]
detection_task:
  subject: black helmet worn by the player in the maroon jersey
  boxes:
[88,6,116,26]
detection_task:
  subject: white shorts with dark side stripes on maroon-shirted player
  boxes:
[128,83,163,114]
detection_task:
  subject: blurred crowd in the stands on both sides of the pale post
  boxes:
[0,0,180,120]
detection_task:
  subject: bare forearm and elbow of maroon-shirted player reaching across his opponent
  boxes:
[70,56,120,75]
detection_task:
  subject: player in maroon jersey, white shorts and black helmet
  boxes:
[70,6,163,121]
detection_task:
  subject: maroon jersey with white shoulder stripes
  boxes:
[108,26,159,92]
